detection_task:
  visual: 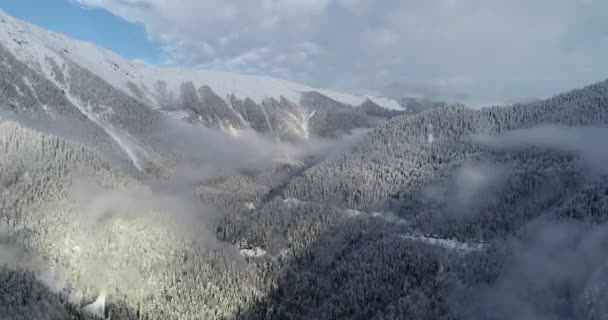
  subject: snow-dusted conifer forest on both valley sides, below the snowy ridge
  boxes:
[0,78,608,319]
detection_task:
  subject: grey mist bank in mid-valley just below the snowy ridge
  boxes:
[146,116,368,179]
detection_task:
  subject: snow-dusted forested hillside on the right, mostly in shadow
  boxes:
[249,82,608,319]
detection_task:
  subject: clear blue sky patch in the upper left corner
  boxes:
[0,0,163,63]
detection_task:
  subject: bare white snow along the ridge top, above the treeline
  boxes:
[0,10,403,110]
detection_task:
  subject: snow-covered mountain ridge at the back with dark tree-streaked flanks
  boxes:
[0,11,406,142]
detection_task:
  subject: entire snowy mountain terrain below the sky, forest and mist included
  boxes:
[0,6,608,320]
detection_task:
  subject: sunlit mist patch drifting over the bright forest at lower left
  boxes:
[68,176,223,248]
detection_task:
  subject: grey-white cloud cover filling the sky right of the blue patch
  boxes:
[76,0,608,106]
